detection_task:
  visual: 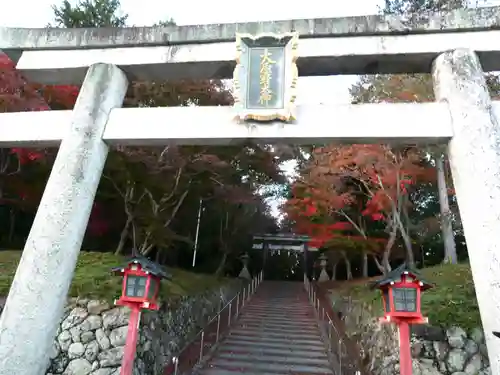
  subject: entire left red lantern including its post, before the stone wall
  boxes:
[112,257,171,375]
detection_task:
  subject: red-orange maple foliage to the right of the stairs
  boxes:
[284,145,434,253]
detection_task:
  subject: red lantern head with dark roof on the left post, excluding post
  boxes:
[112,256,172,310]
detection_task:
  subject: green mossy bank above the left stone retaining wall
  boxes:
[0,251,227,301]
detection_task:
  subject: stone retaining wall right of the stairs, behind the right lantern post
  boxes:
[333,299,491,375]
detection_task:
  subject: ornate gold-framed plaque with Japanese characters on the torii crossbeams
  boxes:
[234,32,299,121]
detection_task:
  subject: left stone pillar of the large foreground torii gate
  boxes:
[0,64,128,375]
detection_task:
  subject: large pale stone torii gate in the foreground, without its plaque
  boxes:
[0,8,500,375]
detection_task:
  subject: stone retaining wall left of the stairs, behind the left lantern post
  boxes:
[0,280,242,375]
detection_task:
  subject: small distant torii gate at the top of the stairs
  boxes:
[252,233,318,279]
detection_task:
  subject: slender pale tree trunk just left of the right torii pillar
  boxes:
[436,155,457,264]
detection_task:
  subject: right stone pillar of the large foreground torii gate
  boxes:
[431,49,500,375]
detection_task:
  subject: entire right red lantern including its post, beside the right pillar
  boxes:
[372,264,433,375]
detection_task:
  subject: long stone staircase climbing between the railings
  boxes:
[198,281,333,375]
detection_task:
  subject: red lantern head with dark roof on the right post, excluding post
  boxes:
[370,263,433,324]
